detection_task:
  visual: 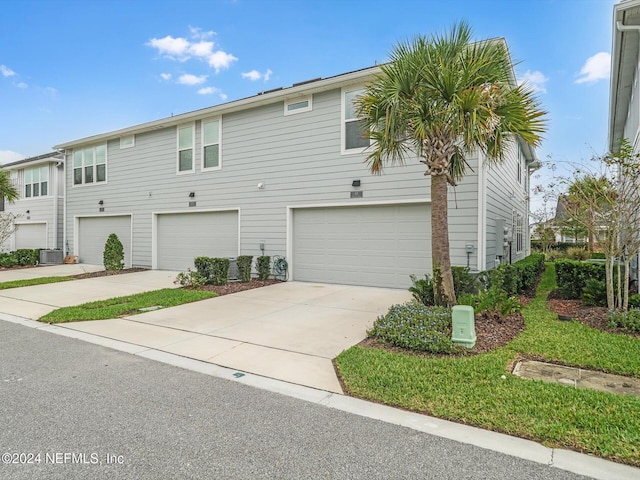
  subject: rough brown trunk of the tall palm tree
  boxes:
[431,174,456,306]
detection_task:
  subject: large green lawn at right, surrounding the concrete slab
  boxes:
[336,265,640,466]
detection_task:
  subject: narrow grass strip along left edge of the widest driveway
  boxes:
[39,288,217,323]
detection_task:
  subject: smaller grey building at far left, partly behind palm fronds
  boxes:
[1,152,64,251]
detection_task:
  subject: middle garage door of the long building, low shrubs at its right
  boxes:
[156,210,238,271]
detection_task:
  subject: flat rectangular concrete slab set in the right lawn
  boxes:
[513,360,640,397]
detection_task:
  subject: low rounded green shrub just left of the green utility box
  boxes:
[367,302,454,353]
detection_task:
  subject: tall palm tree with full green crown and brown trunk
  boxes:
[355,22,546,305]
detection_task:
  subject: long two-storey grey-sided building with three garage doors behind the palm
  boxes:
[56,62,537,288]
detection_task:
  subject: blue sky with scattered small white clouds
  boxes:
[0,0,615,207]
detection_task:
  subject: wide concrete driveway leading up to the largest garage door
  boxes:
[60,282,410,393]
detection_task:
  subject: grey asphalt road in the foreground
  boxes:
[0,320,586,480]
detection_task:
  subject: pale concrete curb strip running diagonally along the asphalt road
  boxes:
[0,314,640,480]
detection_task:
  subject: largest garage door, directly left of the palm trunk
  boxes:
[292,204,431,288]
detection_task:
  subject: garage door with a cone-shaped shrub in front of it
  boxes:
[77,215,131,267]
